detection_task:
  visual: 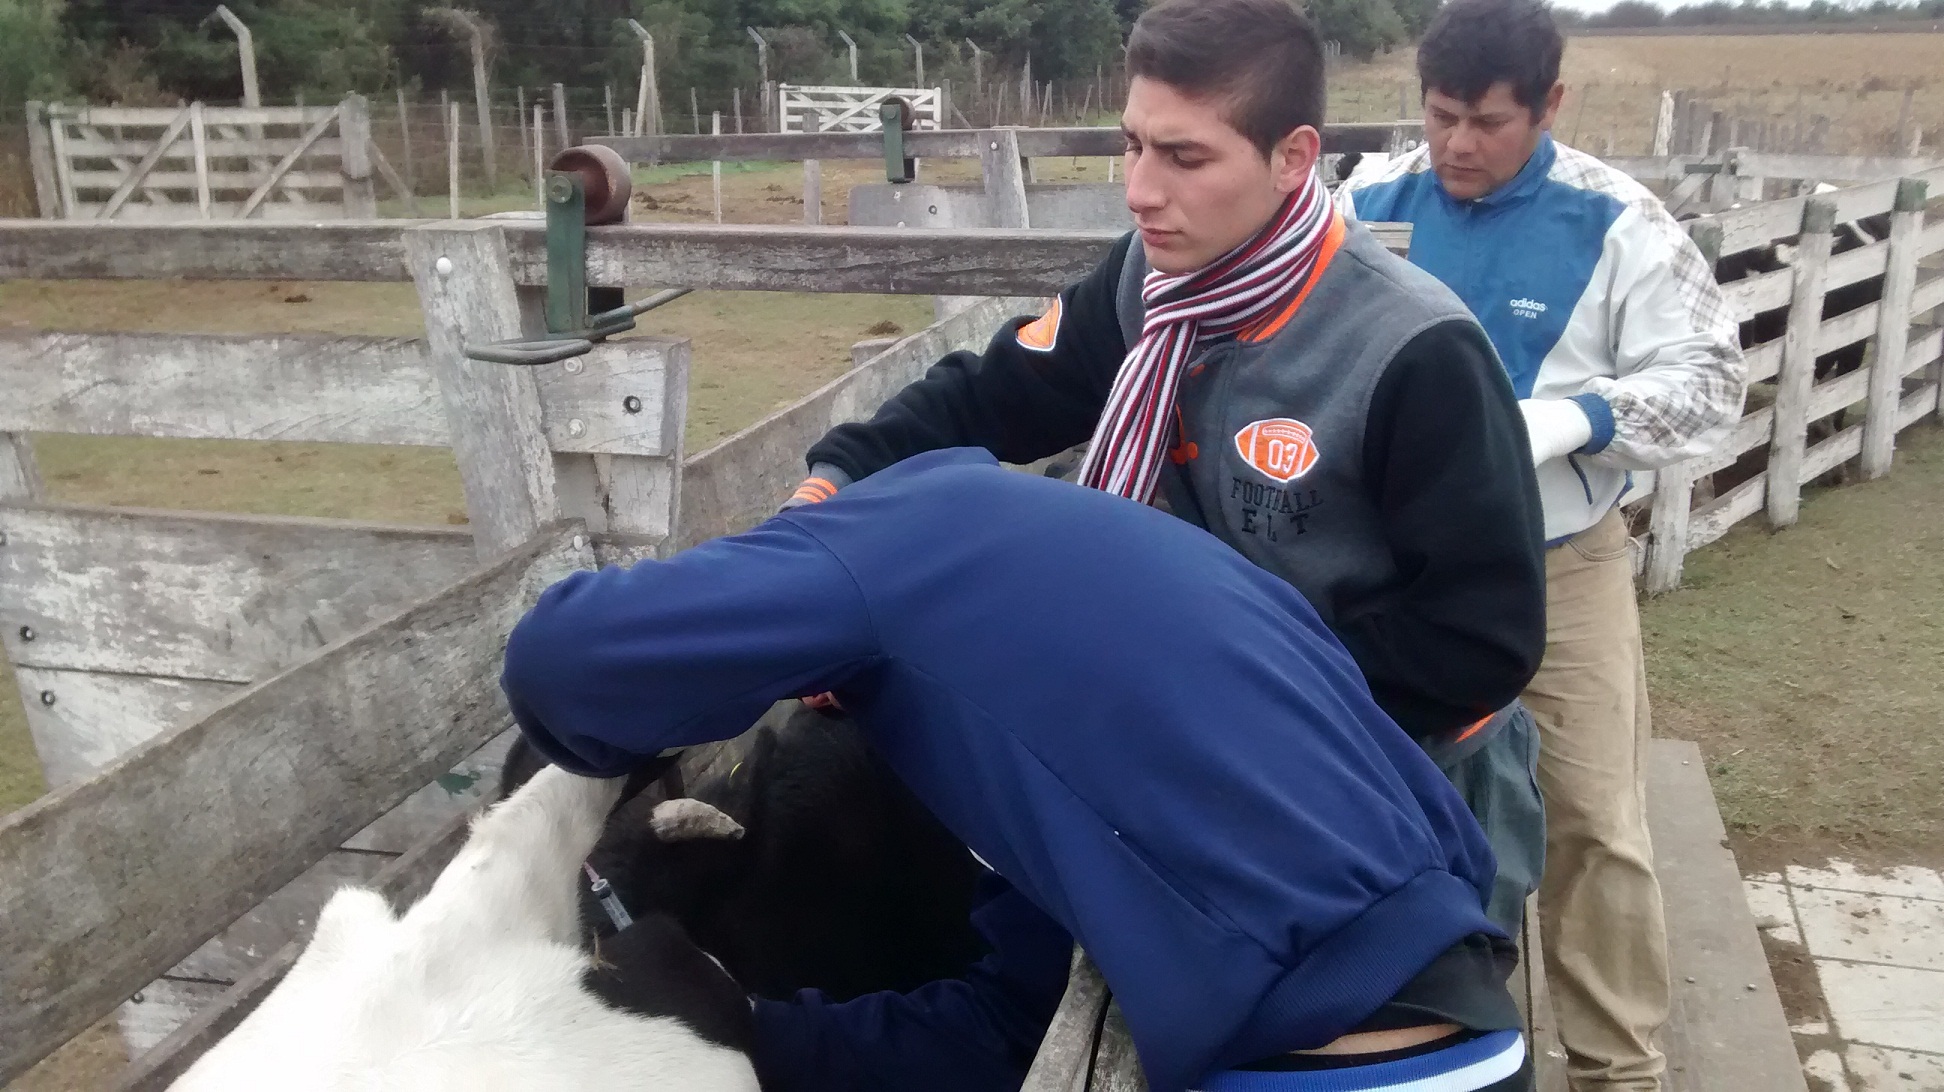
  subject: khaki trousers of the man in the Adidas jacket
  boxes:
[1524,511,1668,1092]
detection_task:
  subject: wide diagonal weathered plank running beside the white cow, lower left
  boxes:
[0,529,593,1080]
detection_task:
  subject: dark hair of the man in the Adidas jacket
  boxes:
[1417,0,1567,120]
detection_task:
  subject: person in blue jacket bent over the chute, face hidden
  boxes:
[503,449,1530,1092]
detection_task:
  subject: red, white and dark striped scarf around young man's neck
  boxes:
[1079,173,1332,503]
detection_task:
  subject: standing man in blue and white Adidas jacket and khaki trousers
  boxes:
[1337,0,1746,1090]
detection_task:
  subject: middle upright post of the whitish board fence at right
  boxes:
[1769,196,1835,529]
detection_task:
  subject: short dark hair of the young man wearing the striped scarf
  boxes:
[1128,0,1324,155]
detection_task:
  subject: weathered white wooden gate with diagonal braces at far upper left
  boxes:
[27,95,391,220]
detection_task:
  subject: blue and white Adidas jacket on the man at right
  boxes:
[1337,136,1746,542]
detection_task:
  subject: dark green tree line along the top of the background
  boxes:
[0,0,1439,116]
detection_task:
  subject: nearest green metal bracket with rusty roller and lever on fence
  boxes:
[465,144,690,367]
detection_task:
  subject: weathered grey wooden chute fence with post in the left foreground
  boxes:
[0,222,1112,1088]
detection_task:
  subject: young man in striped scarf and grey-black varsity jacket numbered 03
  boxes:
[789,0,1545,933]
